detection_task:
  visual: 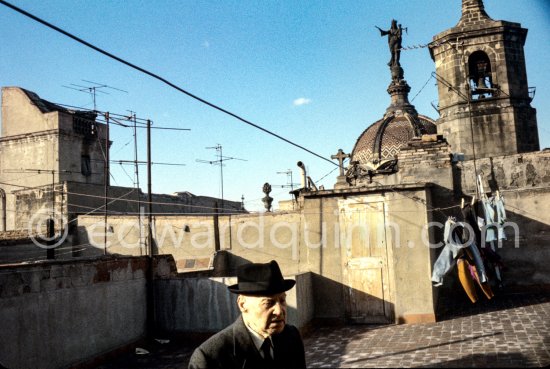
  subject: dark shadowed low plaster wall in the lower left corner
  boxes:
[0,257,147,368]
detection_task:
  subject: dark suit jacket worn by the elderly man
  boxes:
[189,316,306,369]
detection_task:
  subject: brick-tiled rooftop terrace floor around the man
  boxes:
[97,292,550,369]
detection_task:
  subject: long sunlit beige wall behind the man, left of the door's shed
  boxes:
[78,213,301,273]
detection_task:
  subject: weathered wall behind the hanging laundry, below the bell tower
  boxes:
[396,141,550,286]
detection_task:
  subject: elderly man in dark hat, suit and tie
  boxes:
[189,260,306,369]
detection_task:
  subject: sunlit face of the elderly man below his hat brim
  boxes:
[237,292,286,338]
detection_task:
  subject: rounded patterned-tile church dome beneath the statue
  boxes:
[350,112,437,169]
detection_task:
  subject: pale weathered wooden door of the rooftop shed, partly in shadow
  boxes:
[340,200,393,323]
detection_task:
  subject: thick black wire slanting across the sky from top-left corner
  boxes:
[0,0,337,165]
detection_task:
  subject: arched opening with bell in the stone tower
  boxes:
[468,51,496,100]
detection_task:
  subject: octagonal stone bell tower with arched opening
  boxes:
[430,0,539,159]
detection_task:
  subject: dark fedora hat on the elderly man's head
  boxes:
[227,260,296,296]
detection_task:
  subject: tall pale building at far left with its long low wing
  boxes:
[0,87,245,232]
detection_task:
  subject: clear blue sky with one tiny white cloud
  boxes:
[0,0,550,210]
